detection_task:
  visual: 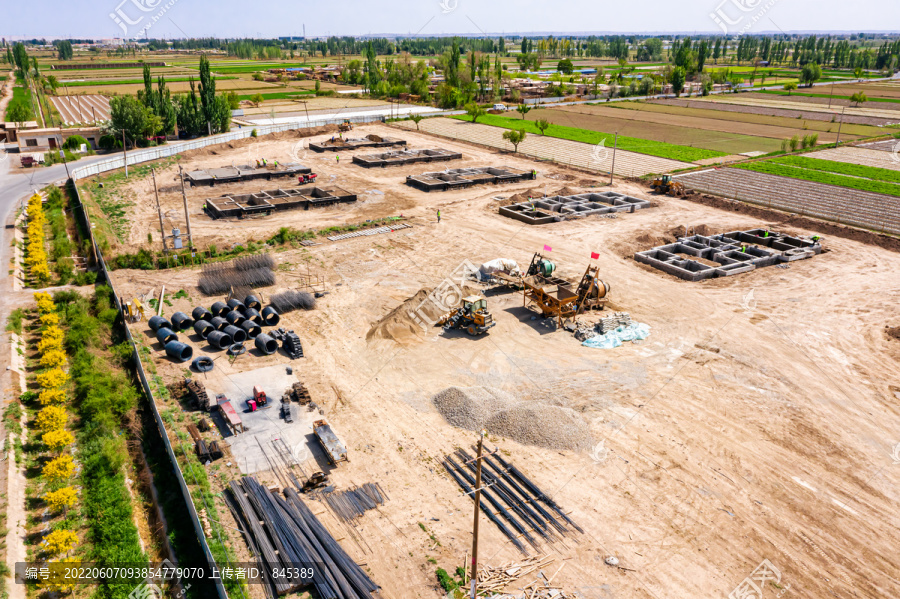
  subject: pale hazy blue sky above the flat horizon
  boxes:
[0,0,900,38]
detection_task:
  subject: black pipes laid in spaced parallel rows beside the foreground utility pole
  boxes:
[444,449,584,555]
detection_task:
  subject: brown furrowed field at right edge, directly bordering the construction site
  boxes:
[678,169,900,235]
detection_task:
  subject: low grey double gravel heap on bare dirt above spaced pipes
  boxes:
[431,387,592,451]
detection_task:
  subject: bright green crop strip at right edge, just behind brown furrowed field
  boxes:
[735,156,900,197]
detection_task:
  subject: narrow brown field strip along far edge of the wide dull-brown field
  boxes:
[609,100,884,139]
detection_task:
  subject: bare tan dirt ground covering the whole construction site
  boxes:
[105,128,900,599]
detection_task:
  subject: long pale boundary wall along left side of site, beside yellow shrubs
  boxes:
[69,183,228,599]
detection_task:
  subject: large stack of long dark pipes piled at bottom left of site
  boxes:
[229,476,380,599]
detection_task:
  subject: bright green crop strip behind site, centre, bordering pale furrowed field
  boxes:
[453,109,726,163]
